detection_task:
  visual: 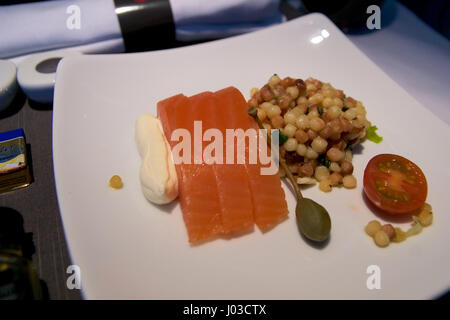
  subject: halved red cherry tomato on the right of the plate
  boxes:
[364,154,428,215]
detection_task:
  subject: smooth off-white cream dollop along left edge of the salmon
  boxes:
[135,113,178,204]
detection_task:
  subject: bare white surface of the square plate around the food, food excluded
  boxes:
[53,14,450,299]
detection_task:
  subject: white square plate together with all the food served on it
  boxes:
[53,14,450,299]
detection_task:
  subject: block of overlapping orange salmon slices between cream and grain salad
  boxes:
[157,87,288,242]
